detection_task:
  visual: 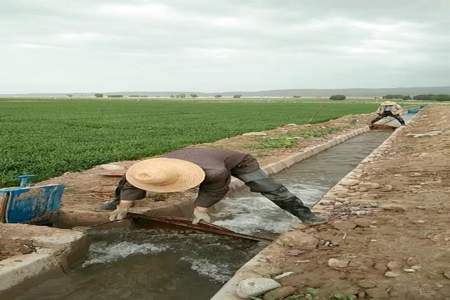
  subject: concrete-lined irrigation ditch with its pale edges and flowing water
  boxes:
[0,113,418,299]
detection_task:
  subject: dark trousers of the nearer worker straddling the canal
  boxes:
[234,169,311,217]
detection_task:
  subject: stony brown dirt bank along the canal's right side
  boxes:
[248,106,450,299]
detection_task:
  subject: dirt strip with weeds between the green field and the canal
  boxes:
[43,115,373,211]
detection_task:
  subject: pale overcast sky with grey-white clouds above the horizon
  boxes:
[0,0,450,93]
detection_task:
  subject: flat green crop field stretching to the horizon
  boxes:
[0,100,377,186]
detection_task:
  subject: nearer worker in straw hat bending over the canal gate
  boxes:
[99,148,325,224]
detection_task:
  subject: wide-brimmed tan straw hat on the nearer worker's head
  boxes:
[125,158,205,193]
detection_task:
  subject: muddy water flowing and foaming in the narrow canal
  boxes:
[15,131,390,300]
